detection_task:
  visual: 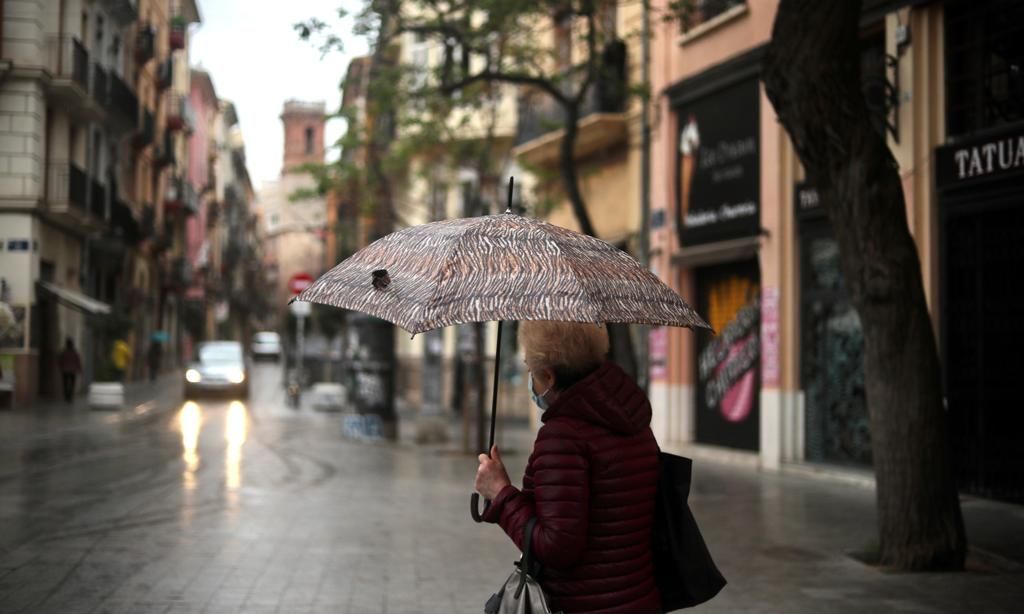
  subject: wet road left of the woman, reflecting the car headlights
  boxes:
[0,364,521,613]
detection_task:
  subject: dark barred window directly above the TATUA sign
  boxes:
[945,0,1024,136]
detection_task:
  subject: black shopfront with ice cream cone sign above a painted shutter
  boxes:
[669,51,761,451]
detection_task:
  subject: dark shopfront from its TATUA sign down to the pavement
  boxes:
[936,126,1024,502]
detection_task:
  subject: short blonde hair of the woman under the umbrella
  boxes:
[519,320,608,388]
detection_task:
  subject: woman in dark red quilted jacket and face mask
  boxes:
[476,321,660,614]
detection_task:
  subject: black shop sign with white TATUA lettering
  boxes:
[935,129,1024,189]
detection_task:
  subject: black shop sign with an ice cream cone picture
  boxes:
[676,78,761,246]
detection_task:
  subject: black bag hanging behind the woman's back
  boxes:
[651,452,725,612]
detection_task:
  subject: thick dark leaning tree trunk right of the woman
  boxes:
[764,0,967,570]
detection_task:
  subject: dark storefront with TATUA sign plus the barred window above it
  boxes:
[934,0,1024,502]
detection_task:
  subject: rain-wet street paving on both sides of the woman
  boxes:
[0,365,1024,613]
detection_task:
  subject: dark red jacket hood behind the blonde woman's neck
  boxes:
[541,362,651,435]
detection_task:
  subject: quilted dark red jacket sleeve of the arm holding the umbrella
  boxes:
[484,421,590,569]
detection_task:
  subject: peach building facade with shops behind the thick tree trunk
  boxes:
[650,0,1024,499]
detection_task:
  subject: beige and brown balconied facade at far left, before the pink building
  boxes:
[0,0,199,403]
